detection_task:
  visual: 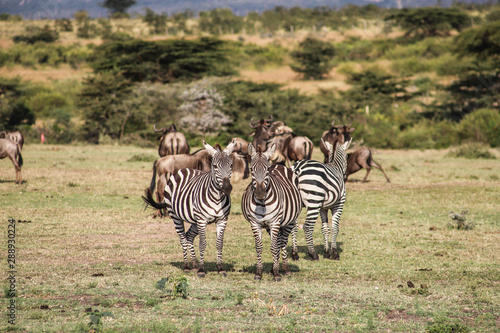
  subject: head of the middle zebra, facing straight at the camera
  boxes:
[248,143,276,200]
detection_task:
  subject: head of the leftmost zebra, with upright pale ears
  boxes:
[203,140,236,196]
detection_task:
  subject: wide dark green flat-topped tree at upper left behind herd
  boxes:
[92,38,234,82]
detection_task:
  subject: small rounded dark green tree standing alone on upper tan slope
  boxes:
[290,37,335,80]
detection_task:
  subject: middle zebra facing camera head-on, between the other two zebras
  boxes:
[241,144,302,281]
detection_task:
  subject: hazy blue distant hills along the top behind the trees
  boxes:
[0,0,488,19]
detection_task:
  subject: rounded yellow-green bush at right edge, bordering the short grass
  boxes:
[459,109,500,147]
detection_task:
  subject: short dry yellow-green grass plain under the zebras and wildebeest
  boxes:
[0,144,500,332]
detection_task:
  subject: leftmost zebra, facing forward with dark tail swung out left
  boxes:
[143,140,235,277]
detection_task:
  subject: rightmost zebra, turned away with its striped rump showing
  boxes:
[292,139,352,260]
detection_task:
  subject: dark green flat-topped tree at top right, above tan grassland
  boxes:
[385,7,470,40]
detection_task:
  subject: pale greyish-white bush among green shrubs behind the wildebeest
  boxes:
[180,80,231,137]
